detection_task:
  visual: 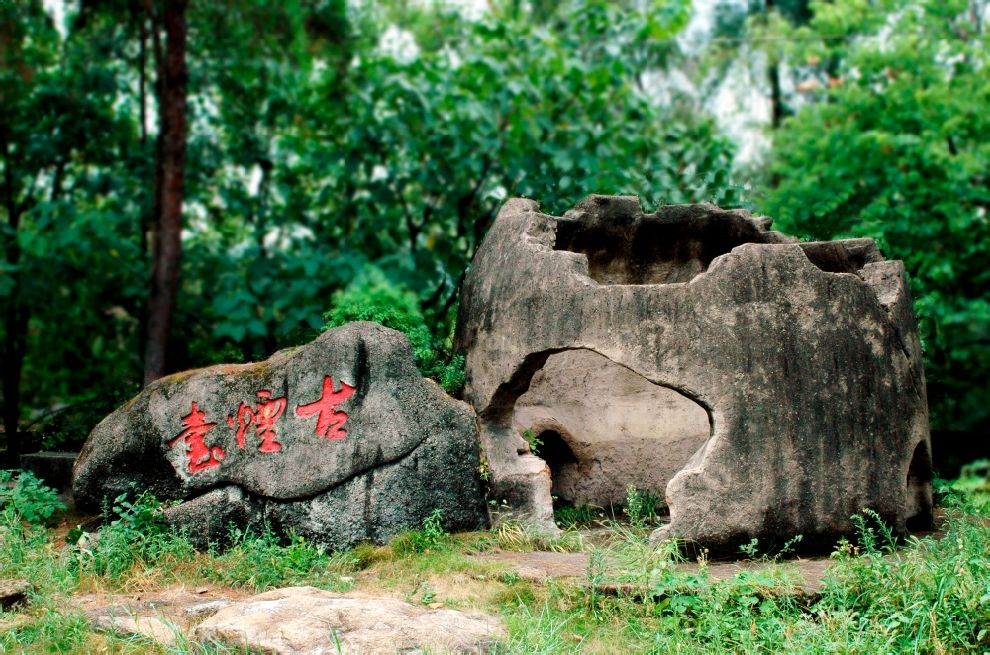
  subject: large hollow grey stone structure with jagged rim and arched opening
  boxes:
[457,196,931,548]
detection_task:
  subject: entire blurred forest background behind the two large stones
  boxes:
[0,0,990,472]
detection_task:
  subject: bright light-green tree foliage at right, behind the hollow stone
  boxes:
[763,0,990,430]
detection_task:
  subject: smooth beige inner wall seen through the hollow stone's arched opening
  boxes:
[512,350,710,507]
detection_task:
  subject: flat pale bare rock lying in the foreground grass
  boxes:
[193,587,506,655]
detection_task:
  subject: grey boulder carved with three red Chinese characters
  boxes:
[73,323,485,548]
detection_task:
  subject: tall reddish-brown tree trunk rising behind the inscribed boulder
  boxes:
[144,0,189,384]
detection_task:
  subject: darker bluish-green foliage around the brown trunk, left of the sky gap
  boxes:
[0,0,737,447]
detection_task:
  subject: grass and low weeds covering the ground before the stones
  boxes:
[0,472,990,653]
